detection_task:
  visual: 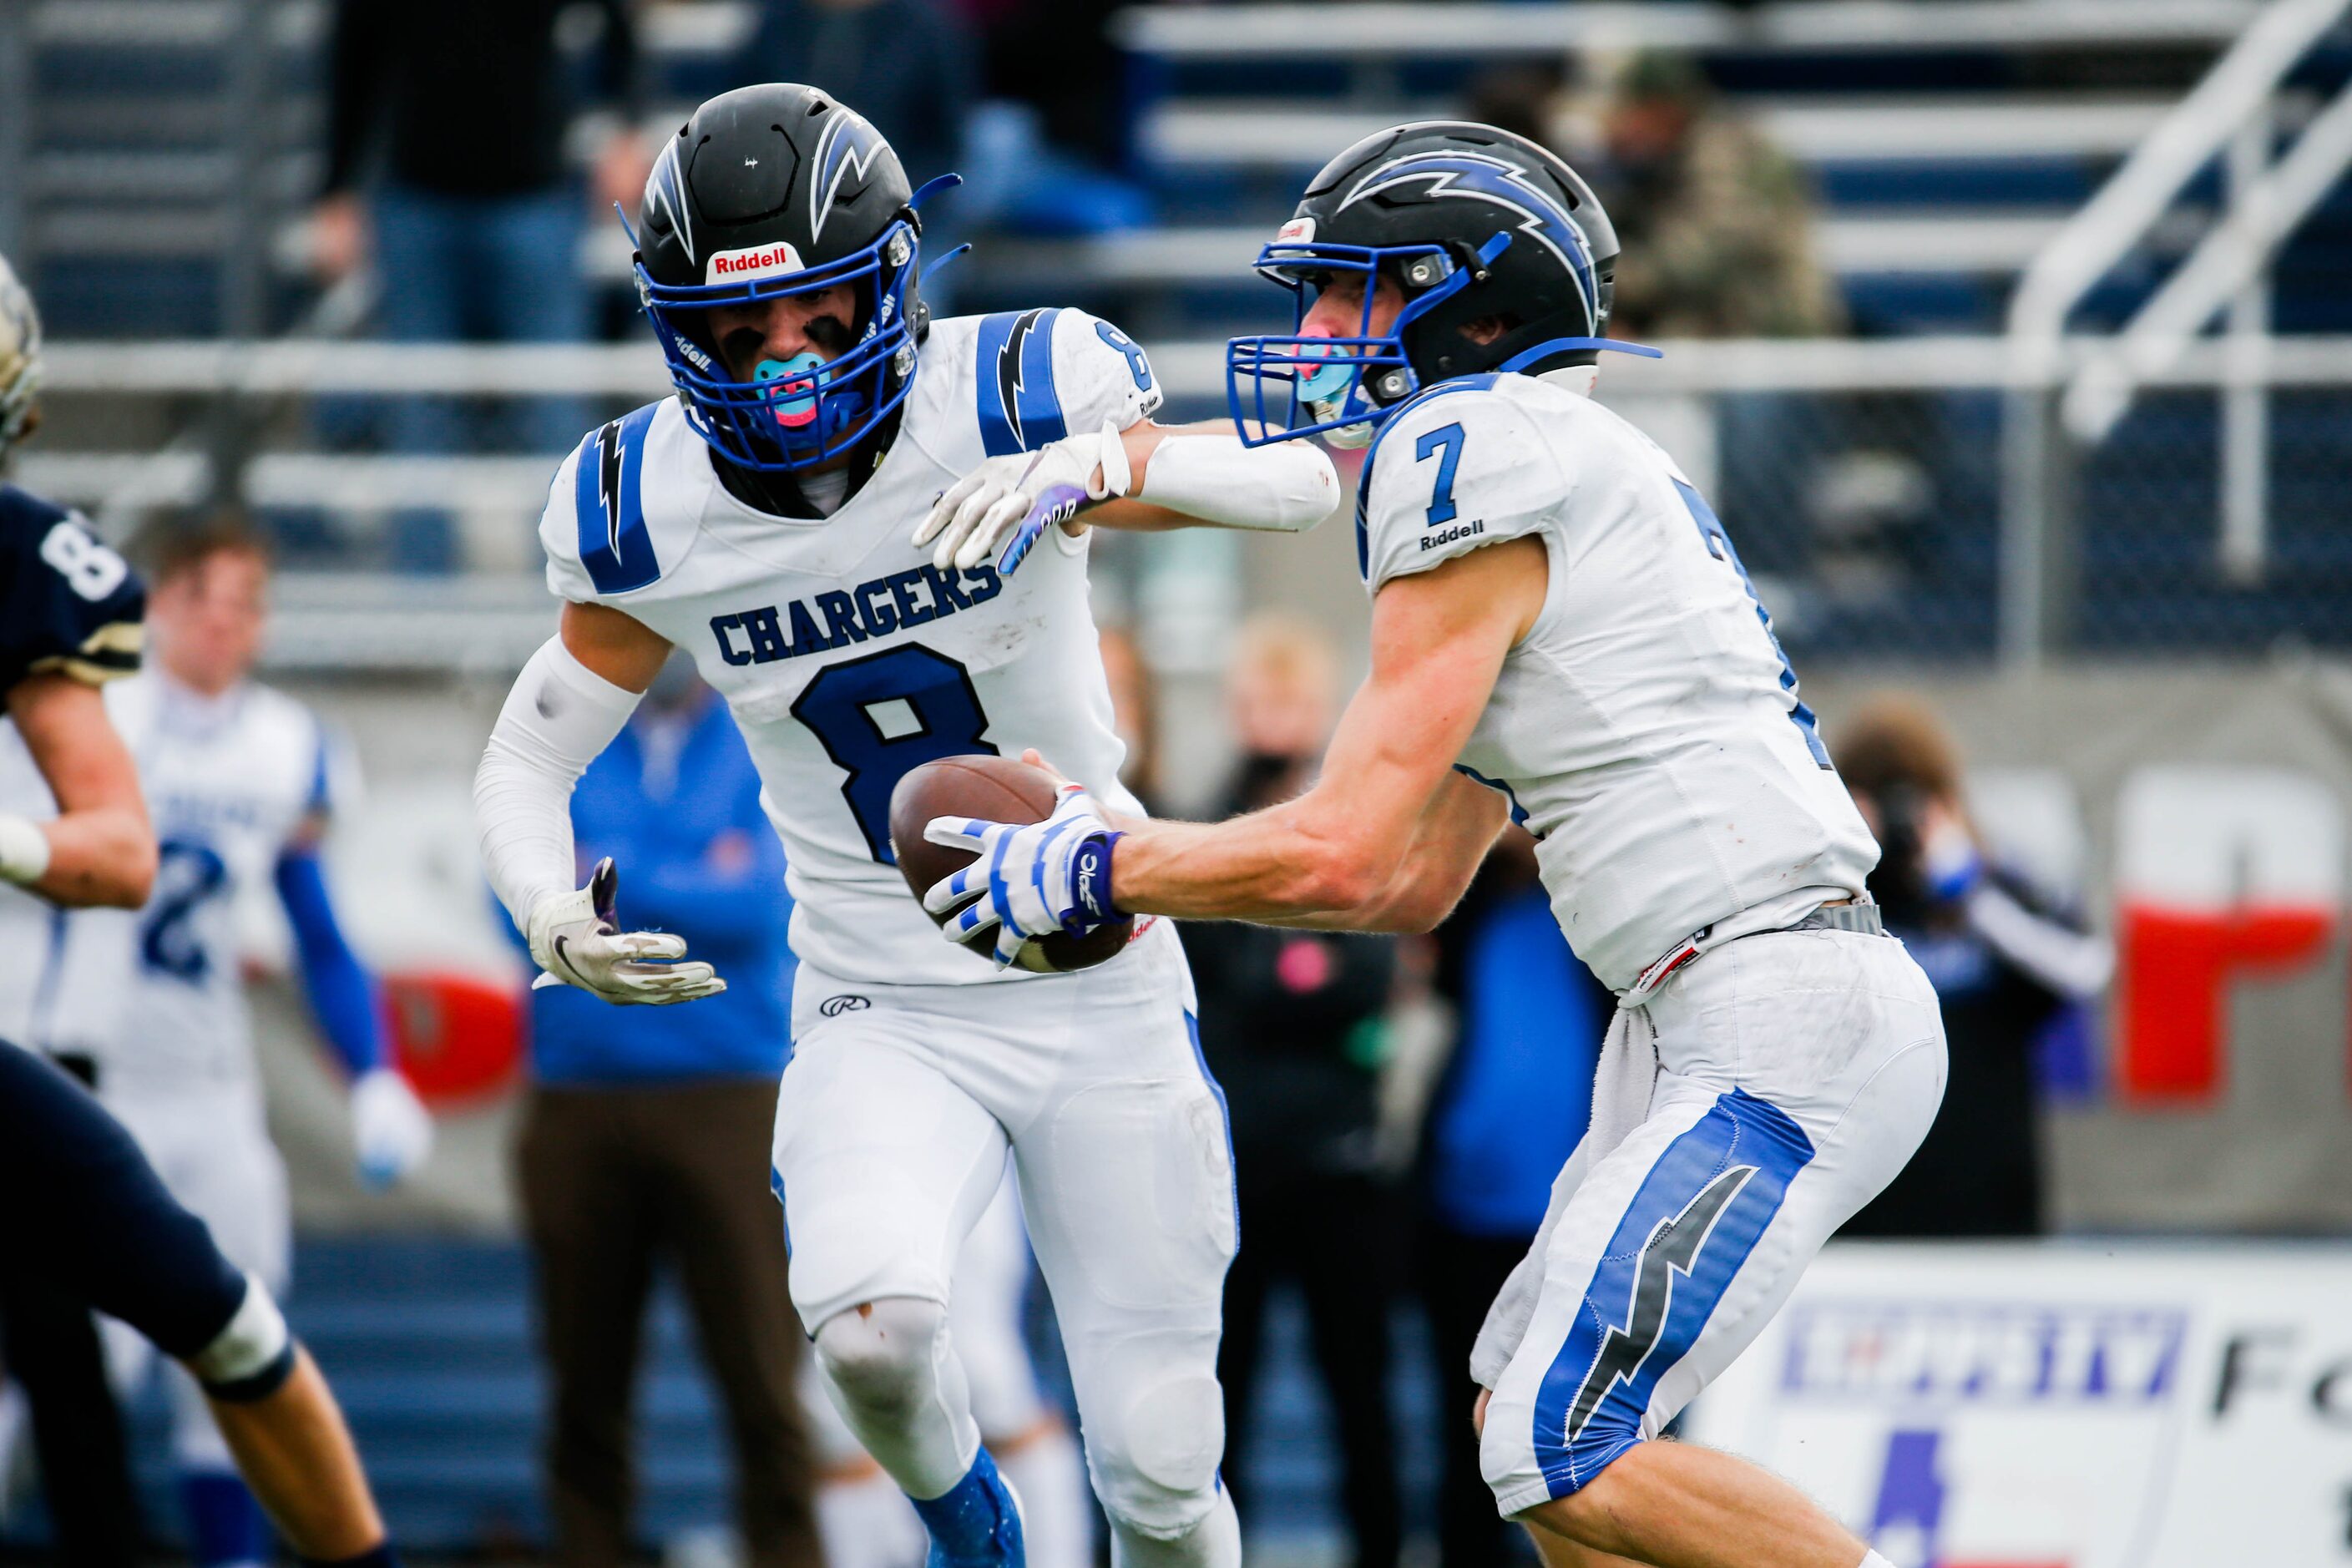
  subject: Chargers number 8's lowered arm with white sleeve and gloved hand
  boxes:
[473,604,726,1004]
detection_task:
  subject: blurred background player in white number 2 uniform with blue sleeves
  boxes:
[0,524,432,1568]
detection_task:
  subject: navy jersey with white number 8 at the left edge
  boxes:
[0,484,146,694]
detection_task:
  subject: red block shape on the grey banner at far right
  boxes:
[2114,905,2335,1103]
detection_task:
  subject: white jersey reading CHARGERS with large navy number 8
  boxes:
[539,311,1160,985]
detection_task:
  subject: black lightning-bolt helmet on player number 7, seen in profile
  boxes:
[1226,120,1658,444]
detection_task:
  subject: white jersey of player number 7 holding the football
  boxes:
[1357,374,1879,989]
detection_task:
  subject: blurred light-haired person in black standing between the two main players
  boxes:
[1183,616,1392,1568]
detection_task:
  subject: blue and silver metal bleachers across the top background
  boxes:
[0,0,2294,338]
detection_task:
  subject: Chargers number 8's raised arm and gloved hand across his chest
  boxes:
[915,418,1338,571]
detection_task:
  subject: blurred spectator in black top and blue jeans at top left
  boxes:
[315,0,647,571]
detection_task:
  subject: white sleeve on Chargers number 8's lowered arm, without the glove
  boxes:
[473,637,640,933]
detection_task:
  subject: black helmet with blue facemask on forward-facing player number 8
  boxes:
[630,83,953,473]
